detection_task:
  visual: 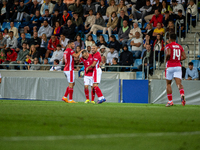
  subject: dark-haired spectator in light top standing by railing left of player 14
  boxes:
[153,34,164,66]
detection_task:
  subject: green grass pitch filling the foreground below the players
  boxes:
[0,100,200,150]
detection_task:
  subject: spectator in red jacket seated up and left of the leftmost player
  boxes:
[45,35,60,58]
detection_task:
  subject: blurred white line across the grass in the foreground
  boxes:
[0,131,200,142]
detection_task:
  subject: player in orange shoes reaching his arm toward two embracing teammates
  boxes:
[62,41,83,103]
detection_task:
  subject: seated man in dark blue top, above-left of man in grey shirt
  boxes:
[24,10,42,33]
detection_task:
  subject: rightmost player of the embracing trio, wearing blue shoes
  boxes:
[86,46,106,104]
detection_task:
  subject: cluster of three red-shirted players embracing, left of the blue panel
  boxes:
[62,41,106,104]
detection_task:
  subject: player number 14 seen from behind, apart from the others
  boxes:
[165,34,186,107]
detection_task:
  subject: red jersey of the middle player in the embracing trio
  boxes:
[80,54,93,77]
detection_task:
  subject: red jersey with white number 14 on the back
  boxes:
[165,42,184,68]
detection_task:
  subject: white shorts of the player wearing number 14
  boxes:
[165,67,182,80]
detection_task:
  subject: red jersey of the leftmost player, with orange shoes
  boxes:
[63,48,74,71]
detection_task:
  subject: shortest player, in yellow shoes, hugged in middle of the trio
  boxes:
[80,50,95,104]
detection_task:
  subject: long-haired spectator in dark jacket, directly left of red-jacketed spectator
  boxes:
[38,33,49,59]
